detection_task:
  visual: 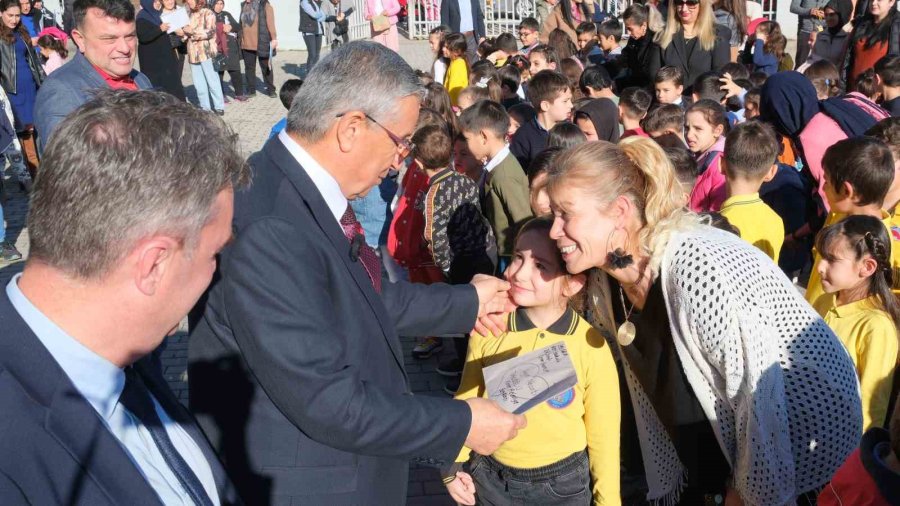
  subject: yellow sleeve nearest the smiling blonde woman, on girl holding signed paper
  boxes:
[582,329,622,505]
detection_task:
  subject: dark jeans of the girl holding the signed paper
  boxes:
[469,451,592,506]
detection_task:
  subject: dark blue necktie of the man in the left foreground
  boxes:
[119,367,213,506]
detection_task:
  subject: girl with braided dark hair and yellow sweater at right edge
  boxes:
[816,215,900,431]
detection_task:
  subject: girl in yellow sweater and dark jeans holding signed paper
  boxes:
[442,217,621,506]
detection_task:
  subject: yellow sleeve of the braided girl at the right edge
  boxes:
[855,314,897,431]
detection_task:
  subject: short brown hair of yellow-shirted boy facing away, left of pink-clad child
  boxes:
[724,121,781,181]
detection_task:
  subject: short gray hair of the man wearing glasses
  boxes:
[287,41,423,142]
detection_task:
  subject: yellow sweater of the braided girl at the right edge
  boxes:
[825,297,897,431]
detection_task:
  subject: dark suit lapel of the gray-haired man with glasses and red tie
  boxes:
[263,137,406,377]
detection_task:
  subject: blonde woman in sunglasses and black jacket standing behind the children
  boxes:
[650,0,731,91]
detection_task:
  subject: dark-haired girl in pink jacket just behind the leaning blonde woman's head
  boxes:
[684,99,728,213]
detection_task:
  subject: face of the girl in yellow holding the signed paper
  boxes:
[504,230,566,307]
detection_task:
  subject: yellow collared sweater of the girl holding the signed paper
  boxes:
[456,308,622,505]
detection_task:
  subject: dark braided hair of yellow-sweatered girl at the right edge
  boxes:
[816,215,900,328]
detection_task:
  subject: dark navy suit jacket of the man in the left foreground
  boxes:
[0,289,240,506]
